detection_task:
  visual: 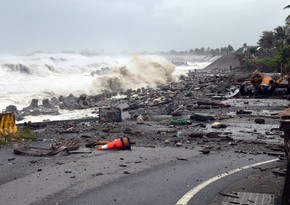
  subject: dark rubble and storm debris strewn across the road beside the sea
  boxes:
[1,61,289,204]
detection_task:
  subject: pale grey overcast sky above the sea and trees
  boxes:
[0,0,290,54]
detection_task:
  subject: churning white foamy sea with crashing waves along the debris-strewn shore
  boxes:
[0,53,212,121]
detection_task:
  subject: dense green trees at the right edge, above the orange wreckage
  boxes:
[236,5,290,75]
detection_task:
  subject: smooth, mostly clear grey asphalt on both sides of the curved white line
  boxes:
[44,151,279,205]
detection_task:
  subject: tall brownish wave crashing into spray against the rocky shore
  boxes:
[92,55,175,93]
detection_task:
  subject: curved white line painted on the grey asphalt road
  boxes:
[176,159,278,205]
